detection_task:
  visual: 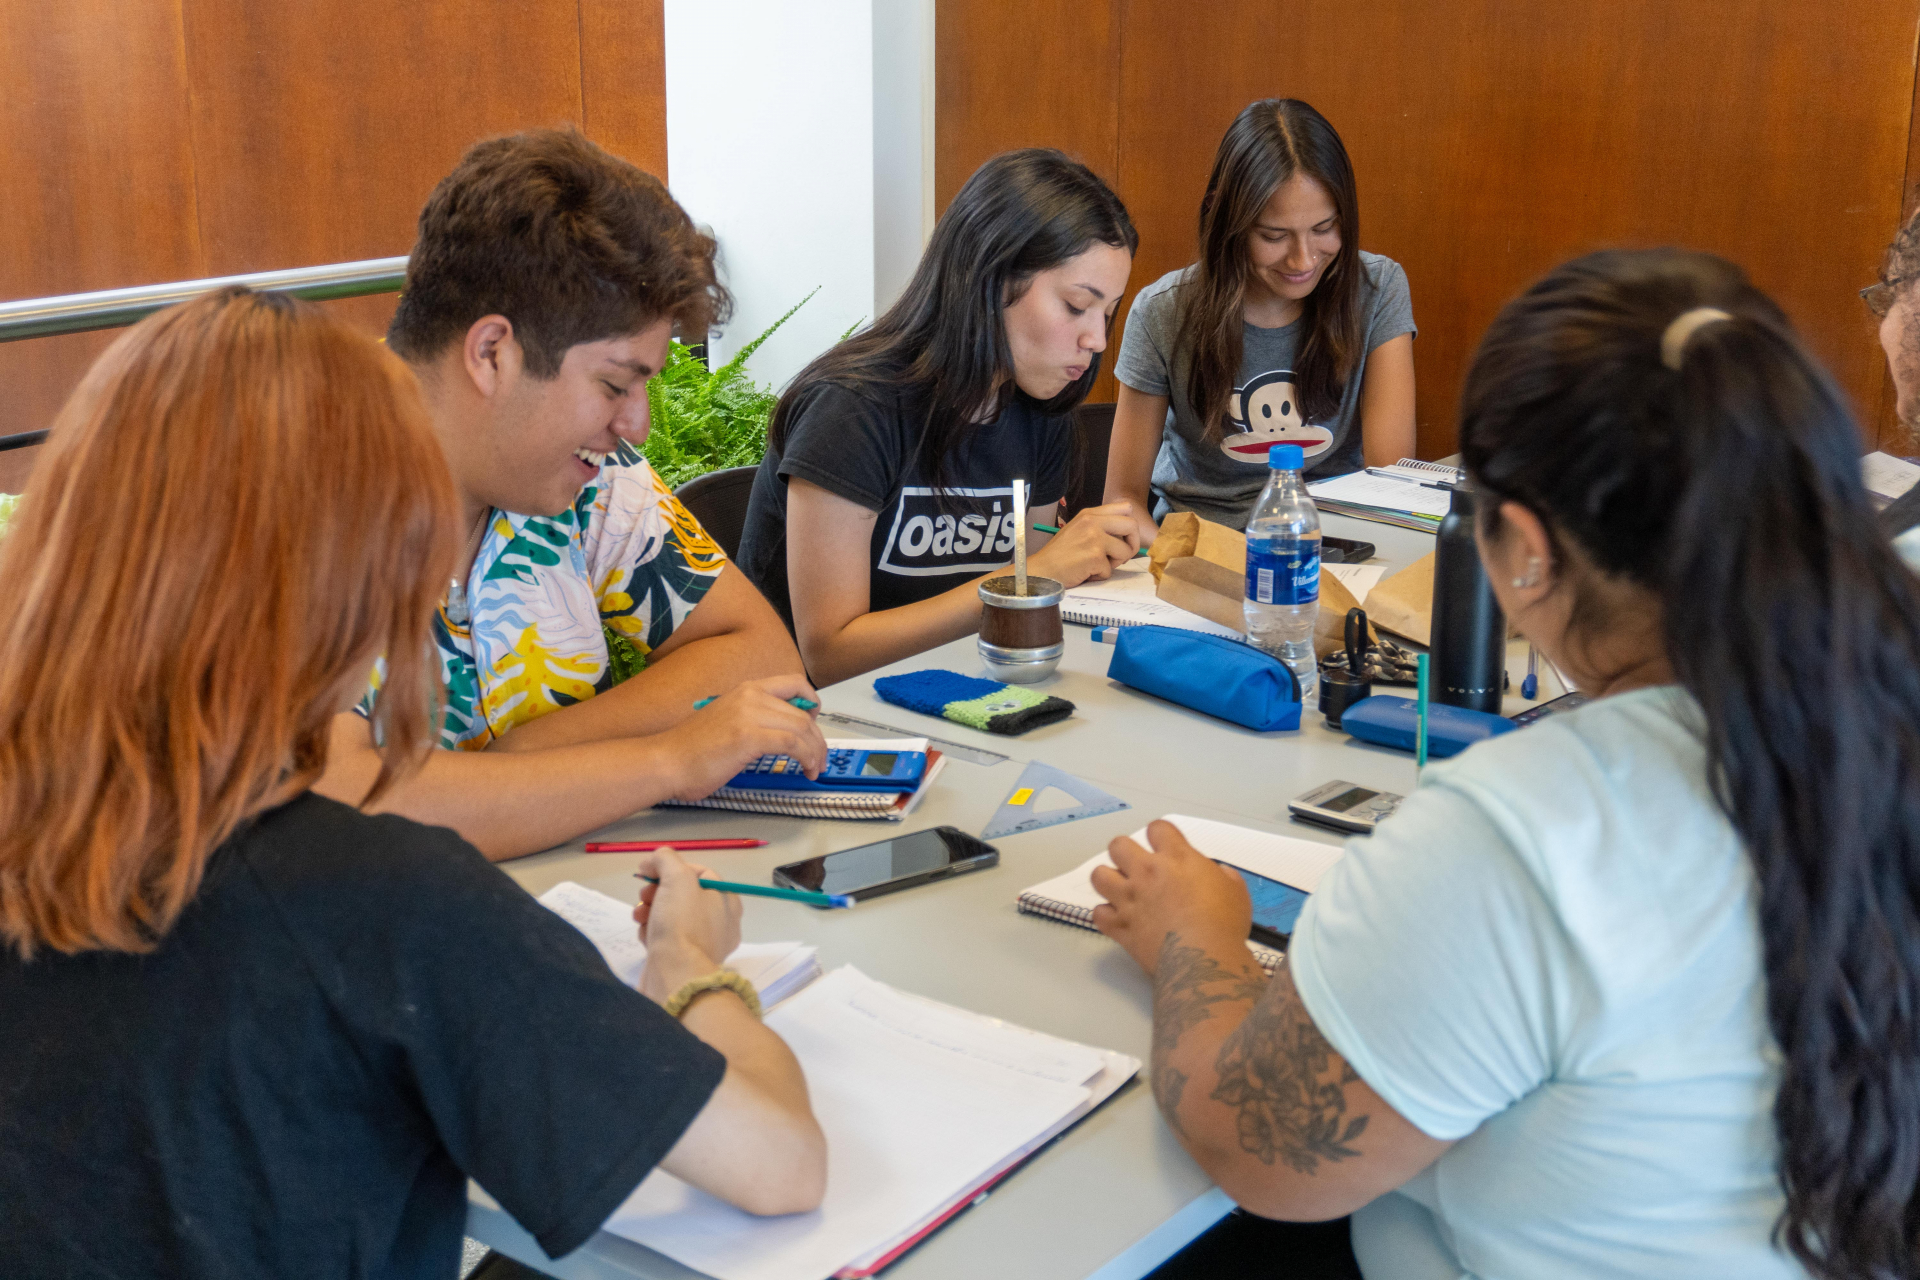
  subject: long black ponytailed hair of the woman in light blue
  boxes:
[1461,249,1920,1280]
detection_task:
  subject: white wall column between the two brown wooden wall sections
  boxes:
[666,0,933,388]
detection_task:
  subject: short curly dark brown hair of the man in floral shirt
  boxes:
[386,129,730,378]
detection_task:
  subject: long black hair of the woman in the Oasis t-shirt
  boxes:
[766,148,1140,489]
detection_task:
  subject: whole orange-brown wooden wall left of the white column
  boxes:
[0,0,666,491]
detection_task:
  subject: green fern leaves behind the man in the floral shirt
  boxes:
[639,290,820,489]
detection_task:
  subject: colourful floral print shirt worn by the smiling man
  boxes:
[361,445,726,750]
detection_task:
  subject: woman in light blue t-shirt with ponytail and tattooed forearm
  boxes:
[1096,251,1920,1280]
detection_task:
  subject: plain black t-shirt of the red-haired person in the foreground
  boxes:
[0,794,726,1280]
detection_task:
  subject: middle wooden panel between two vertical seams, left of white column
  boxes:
[186,0,580,274]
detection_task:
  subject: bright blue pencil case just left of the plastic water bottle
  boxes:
[1106,626,1300,733]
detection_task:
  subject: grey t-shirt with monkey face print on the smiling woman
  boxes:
[1114,249,1419,530]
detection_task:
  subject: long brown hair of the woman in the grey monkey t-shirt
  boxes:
[1179,98,1363,439]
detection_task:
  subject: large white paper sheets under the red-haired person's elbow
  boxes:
[605,965,1140,1280]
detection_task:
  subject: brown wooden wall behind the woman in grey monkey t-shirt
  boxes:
[937,0,1920,457]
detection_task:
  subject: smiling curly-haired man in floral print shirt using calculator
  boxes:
[319,129,826,858]
